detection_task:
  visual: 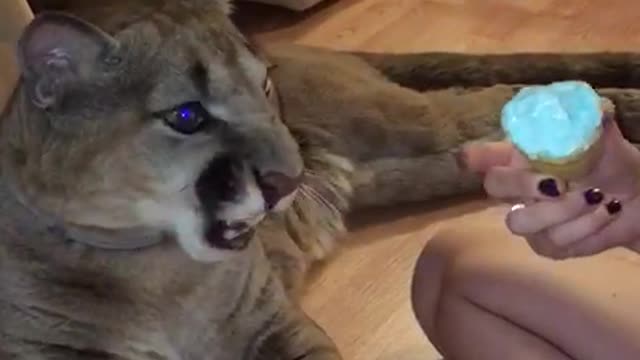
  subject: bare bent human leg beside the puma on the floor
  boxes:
[413,210,640,360]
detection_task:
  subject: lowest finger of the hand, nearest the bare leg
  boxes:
[546,200,618,247]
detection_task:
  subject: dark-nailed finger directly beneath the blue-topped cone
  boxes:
[484,166,567,200]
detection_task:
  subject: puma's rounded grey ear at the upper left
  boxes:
[18,12,118,108]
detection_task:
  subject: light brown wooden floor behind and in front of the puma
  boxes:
[238,0,640,360]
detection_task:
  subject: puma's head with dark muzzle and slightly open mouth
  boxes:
[1,0,303,261]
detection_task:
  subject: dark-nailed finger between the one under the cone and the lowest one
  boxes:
[506,189,604,236]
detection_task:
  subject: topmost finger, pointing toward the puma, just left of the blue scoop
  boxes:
[460,142,513,173]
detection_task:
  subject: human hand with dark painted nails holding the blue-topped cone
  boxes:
[462,115,640,259]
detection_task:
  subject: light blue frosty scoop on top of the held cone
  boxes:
[501,81,602,160]
